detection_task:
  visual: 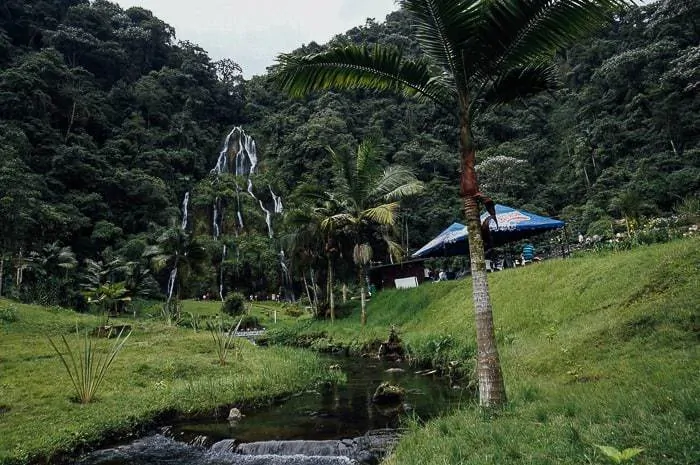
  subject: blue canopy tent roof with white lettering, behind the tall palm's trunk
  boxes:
[411,204,565,258]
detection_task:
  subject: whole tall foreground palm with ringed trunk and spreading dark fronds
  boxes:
[275,0,631,407]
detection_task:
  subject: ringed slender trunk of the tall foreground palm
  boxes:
[460,106,506,407]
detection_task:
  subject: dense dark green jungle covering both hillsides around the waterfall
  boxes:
[0,0,700,308]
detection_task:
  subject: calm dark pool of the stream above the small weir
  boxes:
[172,358,470,442]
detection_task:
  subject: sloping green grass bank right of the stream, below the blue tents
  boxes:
[276,239,700,465]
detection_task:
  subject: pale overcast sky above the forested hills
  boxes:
[116,0,398,78]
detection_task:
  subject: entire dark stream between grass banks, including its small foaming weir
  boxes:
[76,357,471,465]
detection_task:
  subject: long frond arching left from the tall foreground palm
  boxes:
[273,45,456,110]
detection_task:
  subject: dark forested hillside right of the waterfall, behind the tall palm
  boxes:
[246,0,700,237]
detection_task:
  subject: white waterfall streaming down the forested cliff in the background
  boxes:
[211,126,284,302]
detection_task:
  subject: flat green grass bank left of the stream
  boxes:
[0,299,337,464]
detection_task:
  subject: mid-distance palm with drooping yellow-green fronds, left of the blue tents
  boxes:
[320,139,424,326]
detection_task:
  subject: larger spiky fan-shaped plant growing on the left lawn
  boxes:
[49,328,131,404]
